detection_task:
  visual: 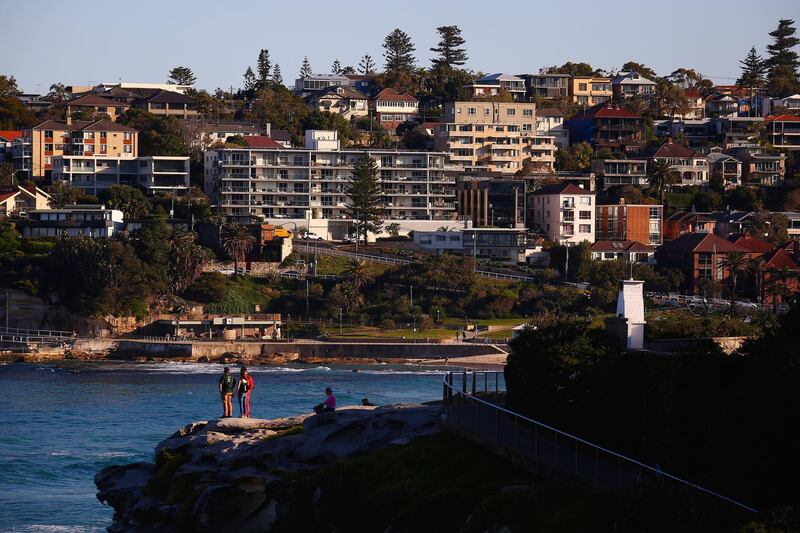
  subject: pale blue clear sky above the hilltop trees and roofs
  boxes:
[6,0,800,93]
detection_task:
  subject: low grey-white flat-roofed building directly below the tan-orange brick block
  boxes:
[52,155,189,195]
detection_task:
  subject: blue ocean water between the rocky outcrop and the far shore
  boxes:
[0,362,442,532]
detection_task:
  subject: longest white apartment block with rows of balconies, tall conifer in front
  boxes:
[205,130,456,229]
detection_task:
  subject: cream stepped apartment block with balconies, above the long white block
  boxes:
[434,102,556,174]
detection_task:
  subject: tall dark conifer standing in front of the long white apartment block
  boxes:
[345,153,384,243]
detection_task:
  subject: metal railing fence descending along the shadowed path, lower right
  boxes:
[442,371,758,513]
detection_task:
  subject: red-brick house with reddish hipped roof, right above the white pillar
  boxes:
[656,233,749,296]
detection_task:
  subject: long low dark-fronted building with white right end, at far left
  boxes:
[19,205,123,239]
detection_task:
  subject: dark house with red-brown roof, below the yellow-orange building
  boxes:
[566,104,645,152]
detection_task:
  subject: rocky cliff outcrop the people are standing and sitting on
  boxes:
[95,405,441,532]
